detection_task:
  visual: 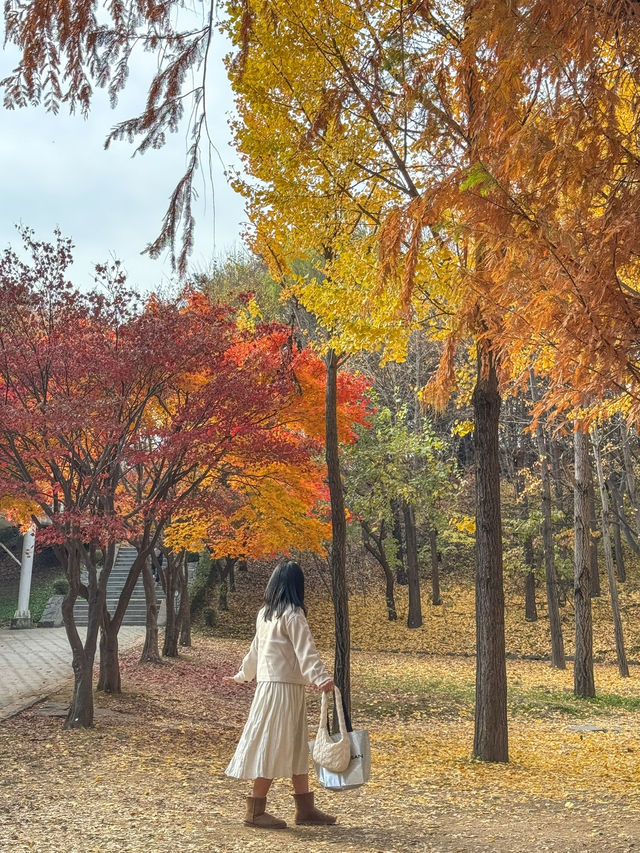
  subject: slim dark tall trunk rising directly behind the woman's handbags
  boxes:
[325,350,351,728]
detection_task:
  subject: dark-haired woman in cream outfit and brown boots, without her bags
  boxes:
[226,560,336,829]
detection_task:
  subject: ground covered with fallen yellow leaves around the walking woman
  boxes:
[0,634,640,853]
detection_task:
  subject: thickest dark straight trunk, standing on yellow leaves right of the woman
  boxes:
[473,340,509,761]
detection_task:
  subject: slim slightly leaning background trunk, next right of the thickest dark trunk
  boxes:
[531,373,567,669]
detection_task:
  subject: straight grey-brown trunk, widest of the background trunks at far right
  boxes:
[573,428,596,699]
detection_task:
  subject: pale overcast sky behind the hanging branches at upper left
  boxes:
[0,23,244,291]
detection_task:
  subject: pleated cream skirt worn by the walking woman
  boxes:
[225,681,309,779]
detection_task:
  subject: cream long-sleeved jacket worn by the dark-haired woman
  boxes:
[233,607,331,686]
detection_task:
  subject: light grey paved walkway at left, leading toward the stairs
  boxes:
[0,625,145,720]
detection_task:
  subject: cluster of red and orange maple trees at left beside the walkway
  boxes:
[0,229,366,727]
